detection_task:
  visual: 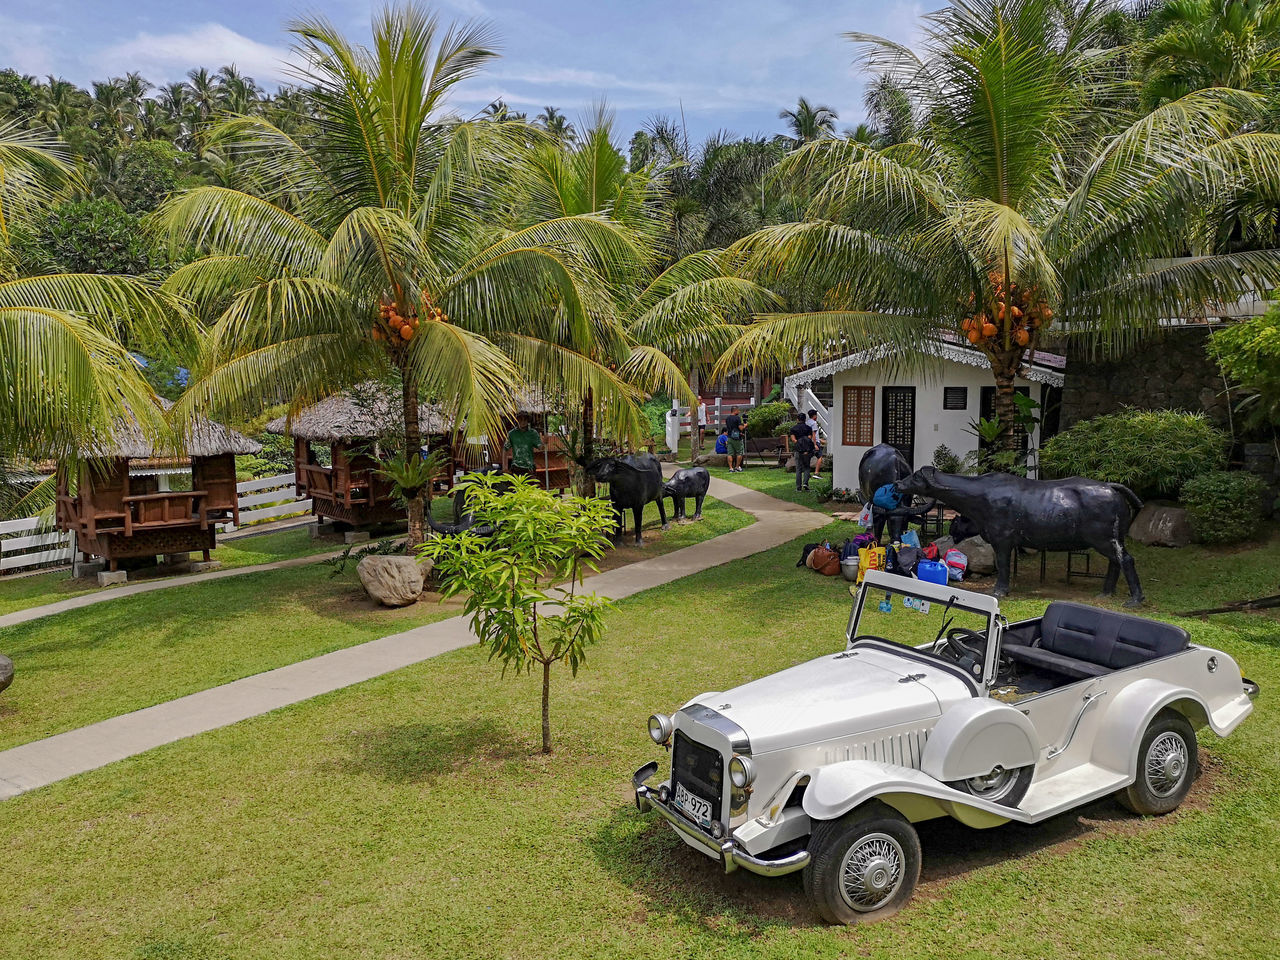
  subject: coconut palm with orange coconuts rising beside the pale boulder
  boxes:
[159,6,634,547]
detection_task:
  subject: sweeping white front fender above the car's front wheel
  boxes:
[800,760,1025,827]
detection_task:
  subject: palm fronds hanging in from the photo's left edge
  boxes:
[0,125,183,458]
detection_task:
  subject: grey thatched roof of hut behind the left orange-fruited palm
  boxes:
[266,383,453,443]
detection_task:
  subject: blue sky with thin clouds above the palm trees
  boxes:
[0,0,936,140]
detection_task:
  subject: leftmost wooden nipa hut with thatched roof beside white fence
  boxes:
[55,401,262,572]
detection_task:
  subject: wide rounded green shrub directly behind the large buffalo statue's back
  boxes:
[1041,408,1228,497]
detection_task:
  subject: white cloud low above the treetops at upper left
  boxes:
[90,23,292,84]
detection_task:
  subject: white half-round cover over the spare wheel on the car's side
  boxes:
[920,698,1039,783]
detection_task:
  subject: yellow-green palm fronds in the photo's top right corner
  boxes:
[1138,0,1280,105]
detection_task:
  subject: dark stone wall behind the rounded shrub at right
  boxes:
[1061,326,1230,430]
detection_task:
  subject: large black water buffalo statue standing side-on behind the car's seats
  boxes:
[896,467,1146,607]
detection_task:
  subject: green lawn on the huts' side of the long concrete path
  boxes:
[0,500,750,749]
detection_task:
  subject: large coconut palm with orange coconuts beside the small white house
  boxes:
[721,0,1280,449]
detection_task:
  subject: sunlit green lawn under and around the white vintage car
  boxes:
[0,525,1280,960]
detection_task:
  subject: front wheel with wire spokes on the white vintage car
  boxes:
[804,800,920,923]
